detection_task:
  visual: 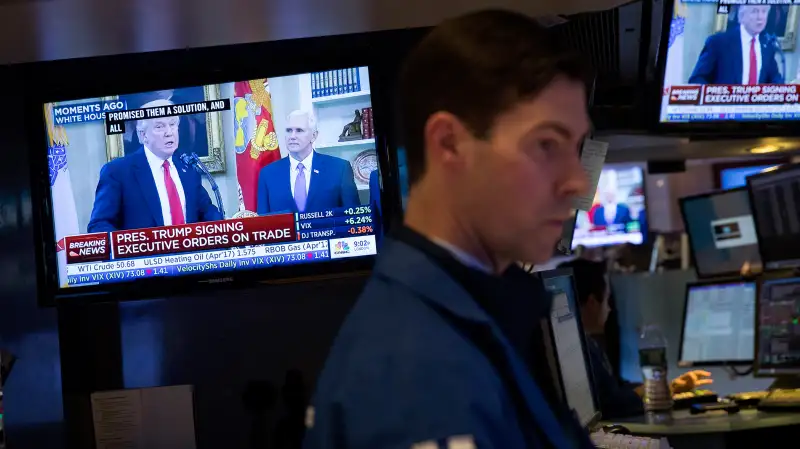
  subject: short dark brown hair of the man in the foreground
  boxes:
[400,10,590,185]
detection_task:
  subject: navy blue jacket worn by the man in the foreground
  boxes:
[304,239,592,449]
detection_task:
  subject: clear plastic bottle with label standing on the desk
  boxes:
[639,324,672,413]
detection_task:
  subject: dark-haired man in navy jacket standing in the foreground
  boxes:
[305,11,591,449]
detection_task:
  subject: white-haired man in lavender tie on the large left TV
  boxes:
[256,111,361,215]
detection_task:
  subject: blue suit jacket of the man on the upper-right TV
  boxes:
[689,26,783,84]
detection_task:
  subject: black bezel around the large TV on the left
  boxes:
[18,30,421,307]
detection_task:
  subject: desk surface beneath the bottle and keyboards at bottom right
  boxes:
[601,409,800,449]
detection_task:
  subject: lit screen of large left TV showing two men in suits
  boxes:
[43,67,380,292]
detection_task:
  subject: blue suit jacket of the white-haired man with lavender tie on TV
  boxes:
[257,152,361,215]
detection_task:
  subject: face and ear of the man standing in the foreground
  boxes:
[453,78,590,263]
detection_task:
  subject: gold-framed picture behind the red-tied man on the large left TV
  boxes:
[103,85,225,173]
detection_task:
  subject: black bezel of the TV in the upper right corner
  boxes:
[646,0,800,139]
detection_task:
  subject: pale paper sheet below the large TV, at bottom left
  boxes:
[92,385,196,449]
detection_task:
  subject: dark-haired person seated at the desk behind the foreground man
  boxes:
[559,259,713,419]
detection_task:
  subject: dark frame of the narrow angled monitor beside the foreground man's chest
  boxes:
[538,268,602,429]
